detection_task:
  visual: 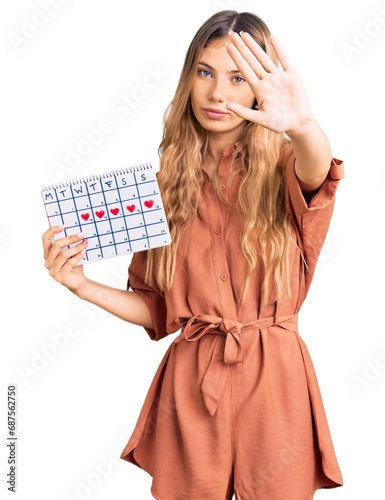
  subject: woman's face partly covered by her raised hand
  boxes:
[191,37,255,142]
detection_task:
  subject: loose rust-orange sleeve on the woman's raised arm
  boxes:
[285,150,345,295]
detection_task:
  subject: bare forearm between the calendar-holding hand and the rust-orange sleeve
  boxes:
[73,278,154,328]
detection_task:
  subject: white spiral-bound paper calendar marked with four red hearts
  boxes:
[41,163,171,265]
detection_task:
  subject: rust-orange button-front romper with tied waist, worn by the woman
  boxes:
[120,143,344,500]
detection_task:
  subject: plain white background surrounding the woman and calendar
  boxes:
[0,0,385,500]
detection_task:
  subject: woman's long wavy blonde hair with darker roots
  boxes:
[138,10,302,304]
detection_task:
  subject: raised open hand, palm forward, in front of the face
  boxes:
[226,32,313,136]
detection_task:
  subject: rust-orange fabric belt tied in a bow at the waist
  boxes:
[174,313,298,415]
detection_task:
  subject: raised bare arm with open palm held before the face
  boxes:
[226,32,332,192]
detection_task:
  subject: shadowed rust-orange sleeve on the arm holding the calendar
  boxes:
[127,250,168,340]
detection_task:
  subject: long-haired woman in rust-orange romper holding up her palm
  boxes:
[43,10,344,500]
